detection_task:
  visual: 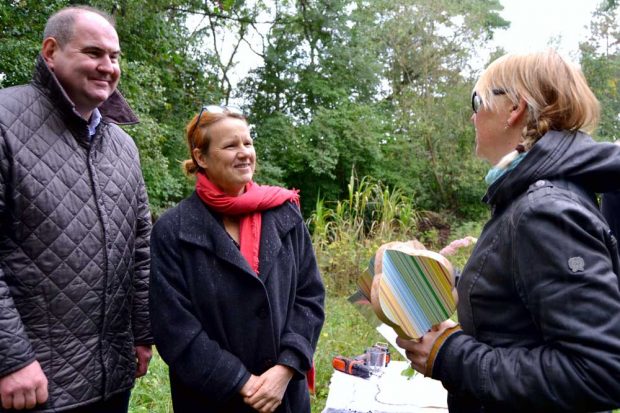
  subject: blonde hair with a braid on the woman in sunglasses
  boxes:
[474,49,600,151]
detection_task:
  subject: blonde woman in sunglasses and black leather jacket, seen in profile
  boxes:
[398,50,620,413]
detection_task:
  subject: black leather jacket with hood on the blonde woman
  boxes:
[432,132,620,413]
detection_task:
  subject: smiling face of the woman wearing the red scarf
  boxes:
[194,118,256,196]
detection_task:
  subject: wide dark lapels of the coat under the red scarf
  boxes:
[179,192,302,282]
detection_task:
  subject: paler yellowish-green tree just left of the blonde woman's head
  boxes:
[356,0,508,216]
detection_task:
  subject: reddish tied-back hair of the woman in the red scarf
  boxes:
[182,111,247,176]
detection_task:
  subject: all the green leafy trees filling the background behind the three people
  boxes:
[0,0,620,222]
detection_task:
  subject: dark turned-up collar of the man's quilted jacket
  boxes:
[32,54,139,125]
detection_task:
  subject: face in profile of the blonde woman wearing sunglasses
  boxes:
[471,90,519,165]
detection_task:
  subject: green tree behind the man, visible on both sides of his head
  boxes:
[0,0,230,214]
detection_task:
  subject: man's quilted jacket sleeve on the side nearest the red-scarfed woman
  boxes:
[132,168,153,345]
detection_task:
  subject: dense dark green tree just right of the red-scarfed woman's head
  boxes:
[240,0,389,211]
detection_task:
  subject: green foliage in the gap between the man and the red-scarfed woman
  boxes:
[103,0,221,212]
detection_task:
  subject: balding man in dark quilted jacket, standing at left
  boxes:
[0,7,152,413]
